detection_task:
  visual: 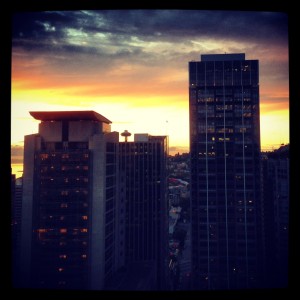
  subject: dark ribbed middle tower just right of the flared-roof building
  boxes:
[119,134,168,290]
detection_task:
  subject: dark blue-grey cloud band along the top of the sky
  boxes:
[13,10,288,53]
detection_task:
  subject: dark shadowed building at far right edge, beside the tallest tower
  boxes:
[262,145,292,288]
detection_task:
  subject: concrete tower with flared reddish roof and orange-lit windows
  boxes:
[21,111,124,289]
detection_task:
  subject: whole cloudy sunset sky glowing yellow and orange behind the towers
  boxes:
[11,10,289,175]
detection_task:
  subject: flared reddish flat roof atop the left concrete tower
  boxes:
[29,110,112,124]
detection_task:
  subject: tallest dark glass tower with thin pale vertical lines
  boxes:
[189,53,263,289]
